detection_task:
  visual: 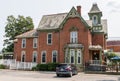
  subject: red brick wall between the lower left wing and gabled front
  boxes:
[38,32,59,63]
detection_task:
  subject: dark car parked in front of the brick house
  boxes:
[56,64,78,77]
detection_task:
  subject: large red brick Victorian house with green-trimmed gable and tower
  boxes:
[14,4,107,66]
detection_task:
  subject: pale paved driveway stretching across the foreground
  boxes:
[0,70,120,81]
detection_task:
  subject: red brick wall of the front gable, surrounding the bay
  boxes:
[60,18,90,62]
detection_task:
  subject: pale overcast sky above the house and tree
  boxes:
[0,0,120,50]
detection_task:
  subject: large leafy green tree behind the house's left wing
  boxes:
[2,15,34,52]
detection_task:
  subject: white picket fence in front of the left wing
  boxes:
[0,59,37,70]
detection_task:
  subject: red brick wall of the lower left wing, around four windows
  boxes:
[14,38,38,62]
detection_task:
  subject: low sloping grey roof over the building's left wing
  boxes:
[16,29,38,38]
